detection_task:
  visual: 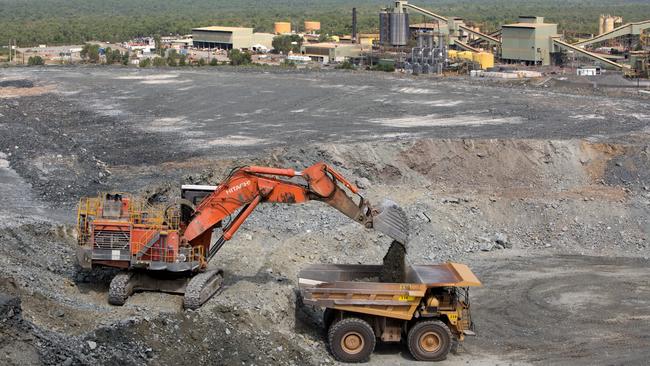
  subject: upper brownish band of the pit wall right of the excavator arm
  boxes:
[323,139,650,193]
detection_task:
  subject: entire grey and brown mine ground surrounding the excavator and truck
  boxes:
[0,67,650,365]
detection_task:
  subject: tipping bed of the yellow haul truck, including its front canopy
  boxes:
[298,263,481,320]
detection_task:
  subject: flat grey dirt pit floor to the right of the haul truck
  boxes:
[472,255,650,365]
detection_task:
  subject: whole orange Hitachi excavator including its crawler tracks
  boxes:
[77,163,408,309]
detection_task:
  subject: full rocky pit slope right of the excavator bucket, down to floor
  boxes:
[308,139,650,263]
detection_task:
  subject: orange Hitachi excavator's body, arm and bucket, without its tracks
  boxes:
[78,163,408,272]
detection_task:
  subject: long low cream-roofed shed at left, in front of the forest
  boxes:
[192,26,274,50]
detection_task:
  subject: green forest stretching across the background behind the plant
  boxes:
[0,0,650,47]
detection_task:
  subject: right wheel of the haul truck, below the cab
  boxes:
[407,320,452,361]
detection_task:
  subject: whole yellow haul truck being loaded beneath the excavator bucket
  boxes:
[299,263,481,362]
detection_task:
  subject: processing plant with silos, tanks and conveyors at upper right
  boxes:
[379,1,650,74]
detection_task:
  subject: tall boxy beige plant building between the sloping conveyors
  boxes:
[501,16,558,65]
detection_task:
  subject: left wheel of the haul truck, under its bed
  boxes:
[327,318,377,363]
